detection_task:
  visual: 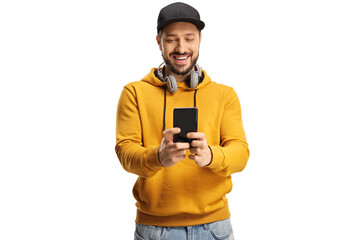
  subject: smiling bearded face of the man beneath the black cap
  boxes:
[156,22,201,75]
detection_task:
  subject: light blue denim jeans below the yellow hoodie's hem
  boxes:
[135,218,234,240]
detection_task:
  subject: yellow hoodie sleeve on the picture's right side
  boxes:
[207,88,250,177]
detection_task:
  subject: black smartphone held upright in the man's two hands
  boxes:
[173,107,198,143]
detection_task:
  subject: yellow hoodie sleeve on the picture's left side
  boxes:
[115,86,162,178]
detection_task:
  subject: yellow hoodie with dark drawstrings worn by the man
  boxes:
[115,68,249,226]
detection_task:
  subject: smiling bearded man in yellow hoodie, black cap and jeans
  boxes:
[115,3,249,240]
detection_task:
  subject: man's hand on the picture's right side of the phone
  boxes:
[187,132,212,167]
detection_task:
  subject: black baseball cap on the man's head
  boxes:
[157,2,205,32]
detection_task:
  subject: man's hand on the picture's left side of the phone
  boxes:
[159,128,190,167]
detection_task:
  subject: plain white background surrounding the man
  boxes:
[0,0,360,240]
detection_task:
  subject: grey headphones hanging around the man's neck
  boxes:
[157,62,202,93]
